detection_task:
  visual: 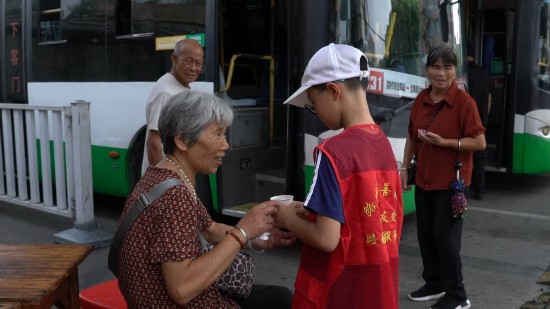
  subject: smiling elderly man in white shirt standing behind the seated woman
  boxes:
[141,39,204,174]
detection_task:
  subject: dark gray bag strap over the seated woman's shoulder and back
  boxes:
[108,178,183,277]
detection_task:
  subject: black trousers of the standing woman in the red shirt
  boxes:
[415,187,467,301]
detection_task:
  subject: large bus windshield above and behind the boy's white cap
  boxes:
[331,0,454,79]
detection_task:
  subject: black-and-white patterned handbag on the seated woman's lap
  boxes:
[199,235,256,298]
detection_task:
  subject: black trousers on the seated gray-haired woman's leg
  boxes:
[233,284,292,309]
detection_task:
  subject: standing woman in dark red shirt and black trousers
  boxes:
[401,47,485,309]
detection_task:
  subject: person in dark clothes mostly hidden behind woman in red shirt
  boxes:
[468,44,491,200]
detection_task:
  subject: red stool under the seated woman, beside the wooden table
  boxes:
[80,279,127,309]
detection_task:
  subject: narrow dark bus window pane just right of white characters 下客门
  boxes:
[40,0,61,43]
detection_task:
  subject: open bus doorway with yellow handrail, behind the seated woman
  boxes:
[211,0,288,217]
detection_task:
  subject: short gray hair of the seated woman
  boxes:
[162,89,233,154]
